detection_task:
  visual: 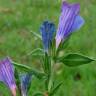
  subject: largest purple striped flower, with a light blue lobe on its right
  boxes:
[56,2,84,48]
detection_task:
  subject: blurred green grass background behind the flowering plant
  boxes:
[0,0,96,96]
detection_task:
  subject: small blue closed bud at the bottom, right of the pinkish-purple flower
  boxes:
[20,73,32,96]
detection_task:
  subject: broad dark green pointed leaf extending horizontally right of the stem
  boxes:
[58,54,94,67]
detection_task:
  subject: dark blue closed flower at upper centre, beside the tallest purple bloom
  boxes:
[40,21,56,53]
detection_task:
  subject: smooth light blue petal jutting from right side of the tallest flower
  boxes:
[71,15,85,32]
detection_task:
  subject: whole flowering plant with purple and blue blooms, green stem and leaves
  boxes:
[0,2,94,96]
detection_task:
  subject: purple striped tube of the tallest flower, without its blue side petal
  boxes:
[56,2,80,48]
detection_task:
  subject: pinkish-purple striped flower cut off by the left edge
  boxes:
[0,57,16,96]
